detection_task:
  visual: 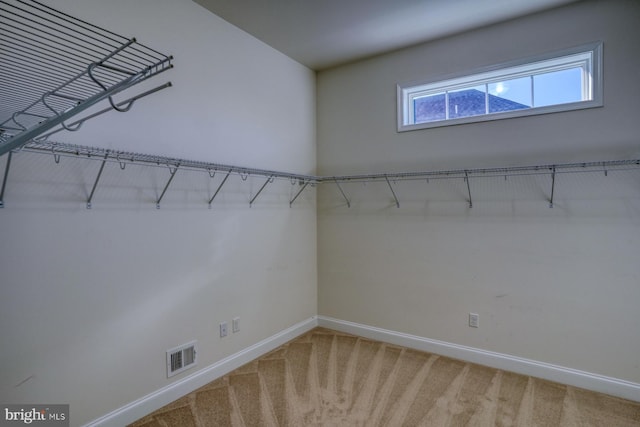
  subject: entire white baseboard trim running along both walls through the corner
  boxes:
[83,316,640,427]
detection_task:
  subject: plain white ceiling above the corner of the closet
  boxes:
[194,0,576,70]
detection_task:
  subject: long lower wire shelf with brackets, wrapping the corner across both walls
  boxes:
[0,141,640,209]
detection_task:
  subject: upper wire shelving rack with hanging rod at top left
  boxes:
[0,0,172,156]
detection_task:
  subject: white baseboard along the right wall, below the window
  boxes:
[318,316,640,402]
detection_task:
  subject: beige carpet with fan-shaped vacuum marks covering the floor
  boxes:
[132,328,640,427]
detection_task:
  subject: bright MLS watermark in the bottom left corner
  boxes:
[0,404,69,427]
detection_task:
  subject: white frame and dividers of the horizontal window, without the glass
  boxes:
[397,42,603,132]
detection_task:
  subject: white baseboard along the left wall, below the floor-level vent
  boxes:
[84,316,318,427]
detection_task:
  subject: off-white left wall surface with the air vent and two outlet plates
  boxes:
[0,0,317,426]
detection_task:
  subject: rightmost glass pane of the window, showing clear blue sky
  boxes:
[533,67,583,107]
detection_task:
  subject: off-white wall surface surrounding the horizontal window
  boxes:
[317,0,640,383]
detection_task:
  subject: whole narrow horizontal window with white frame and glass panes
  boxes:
[398,43,602,132]
